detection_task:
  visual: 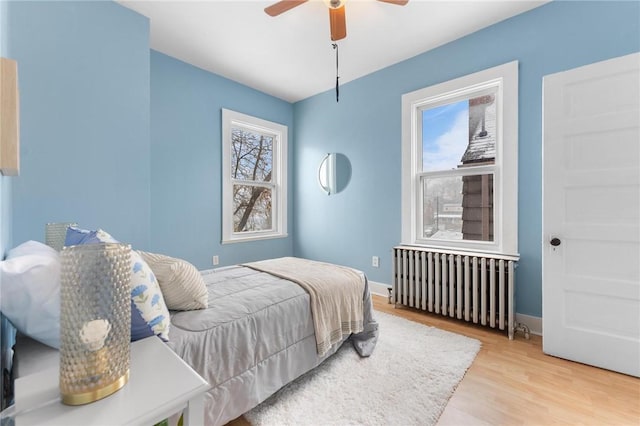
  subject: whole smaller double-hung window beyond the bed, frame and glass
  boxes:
[222,109,287,243]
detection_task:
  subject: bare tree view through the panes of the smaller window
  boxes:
[231,128,274,232]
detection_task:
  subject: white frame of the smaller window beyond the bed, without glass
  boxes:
[222,108,288,244]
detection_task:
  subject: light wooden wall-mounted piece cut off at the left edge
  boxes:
[0,58,20,176]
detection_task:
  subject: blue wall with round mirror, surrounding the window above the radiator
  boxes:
[294,1,640,316]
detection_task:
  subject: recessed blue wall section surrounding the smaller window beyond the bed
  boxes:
[151,51,295,269]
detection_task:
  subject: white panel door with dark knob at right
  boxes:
[542,54,640,376]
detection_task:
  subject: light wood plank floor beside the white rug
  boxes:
[229,296,640,426]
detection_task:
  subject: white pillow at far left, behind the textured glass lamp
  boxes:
[0,241,60,349]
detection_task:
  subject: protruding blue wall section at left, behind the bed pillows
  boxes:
[7,1,150,248]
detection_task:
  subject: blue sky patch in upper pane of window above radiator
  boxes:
[422,100,469,171]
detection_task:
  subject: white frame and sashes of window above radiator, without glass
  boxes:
[401,61,518,255]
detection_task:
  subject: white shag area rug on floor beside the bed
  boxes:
[245,311,480,426]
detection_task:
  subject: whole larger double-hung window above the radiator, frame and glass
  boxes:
[402,62,518,254]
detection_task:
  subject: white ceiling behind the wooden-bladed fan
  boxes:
[118,0,549,102]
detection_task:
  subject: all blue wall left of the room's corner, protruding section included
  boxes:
[2,1,293,268]
